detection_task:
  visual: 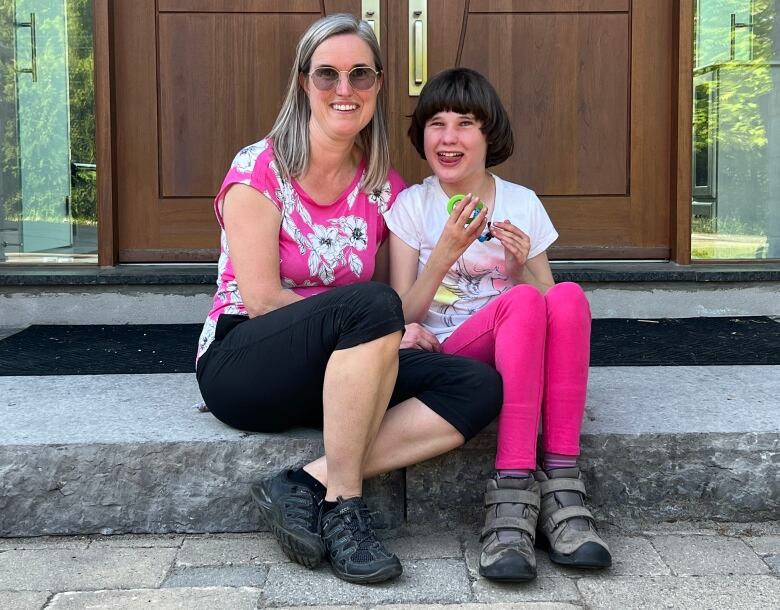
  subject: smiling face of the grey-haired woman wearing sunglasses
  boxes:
[301,34,382,140]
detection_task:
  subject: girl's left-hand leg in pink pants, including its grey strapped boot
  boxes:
[442,285,547,581]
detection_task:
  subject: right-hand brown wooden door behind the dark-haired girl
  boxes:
[388,0,673,258]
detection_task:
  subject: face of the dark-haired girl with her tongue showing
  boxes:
[423,111,487,188]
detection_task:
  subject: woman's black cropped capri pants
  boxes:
[197,282,502,440]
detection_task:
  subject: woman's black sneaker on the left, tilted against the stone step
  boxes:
[252,470,325,568]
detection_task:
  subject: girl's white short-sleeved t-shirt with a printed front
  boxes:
[385,175,558,341]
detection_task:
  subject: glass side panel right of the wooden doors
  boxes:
[691,0,780,260]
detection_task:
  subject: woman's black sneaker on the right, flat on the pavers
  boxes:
[320,497,403,584]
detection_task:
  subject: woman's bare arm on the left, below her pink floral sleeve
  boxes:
[222,184,303,318]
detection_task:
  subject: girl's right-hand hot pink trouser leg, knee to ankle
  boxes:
[542,282,590,459]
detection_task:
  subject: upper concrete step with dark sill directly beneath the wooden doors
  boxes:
[0,261,780,328]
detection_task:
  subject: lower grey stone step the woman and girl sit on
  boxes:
[0,366,780,536]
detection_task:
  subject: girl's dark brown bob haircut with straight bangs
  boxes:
[408,68,515,167]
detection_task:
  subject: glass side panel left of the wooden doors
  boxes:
[0,0,97,264]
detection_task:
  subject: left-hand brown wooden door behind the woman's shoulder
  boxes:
[113,0,360,262]
